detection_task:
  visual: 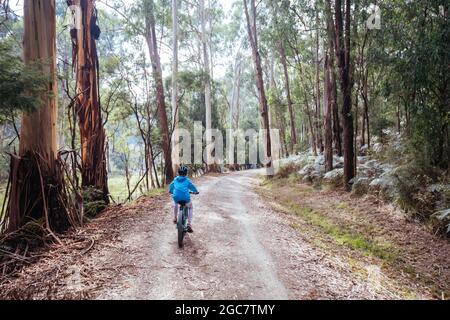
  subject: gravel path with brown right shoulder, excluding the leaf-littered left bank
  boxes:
[98,171,428,299]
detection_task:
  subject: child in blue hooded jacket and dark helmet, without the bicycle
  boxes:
[169,166,199,233]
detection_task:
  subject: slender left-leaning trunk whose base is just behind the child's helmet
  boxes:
[144,0,174,184]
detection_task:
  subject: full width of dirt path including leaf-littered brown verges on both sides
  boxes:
[0,171,438,299]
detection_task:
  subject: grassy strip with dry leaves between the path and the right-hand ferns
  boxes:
[258,175,450,299]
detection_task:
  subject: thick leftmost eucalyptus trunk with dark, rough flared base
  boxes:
[5,0,69,232]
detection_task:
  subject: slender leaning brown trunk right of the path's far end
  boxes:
[244,0,274,176]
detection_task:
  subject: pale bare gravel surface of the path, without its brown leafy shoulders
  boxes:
[99,173,288,299]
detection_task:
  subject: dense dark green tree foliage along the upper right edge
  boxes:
[369,0,450,169]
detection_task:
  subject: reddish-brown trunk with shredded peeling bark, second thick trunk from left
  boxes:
[68,0,109,203]
